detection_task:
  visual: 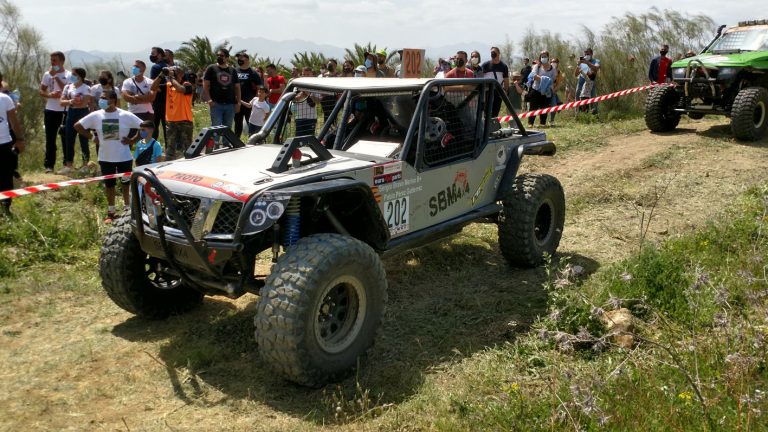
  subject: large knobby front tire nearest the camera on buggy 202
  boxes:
[254,234,387,387]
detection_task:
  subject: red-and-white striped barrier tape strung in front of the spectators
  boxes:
[0,84,669,201]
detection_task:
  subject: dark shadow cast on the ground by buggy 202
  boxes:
[113,235,598,423]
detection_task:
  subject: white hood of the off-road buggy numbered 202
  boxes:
[140,144,377,202]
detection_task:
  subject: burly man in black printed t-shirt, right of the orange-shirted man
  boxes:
[203,48,240,129]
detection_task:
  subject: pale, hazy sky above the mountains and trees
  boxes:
[11,0,768,52]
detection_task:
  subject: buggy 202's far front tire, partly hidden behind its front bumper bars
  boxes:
[99,214,203,319]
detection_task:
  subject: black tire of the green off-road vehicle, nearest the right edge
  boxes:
[731,87,768,141]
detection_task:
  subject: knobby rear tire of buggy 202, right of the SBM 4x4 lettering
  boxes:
[499,174,565,267]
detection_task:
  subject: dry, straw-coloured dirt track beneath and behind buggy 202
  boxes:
[0,119,768,431]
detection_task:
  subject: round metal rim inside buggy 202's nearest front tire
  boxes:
[313,275,367,354]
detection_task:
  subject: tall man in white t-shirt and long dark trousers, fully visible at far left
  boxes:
[40,51,70,173]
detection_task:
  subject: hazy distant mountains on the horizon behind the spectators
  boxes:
[65,36,491,71]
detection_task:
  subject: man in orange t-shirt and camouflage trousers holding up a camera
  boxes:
[152,66,195,160]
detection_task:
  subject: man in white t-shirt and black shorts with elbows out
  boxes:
[75,90,141,223]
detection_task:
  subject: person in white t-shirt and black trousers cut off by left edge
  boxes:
[0,93,24,214]
